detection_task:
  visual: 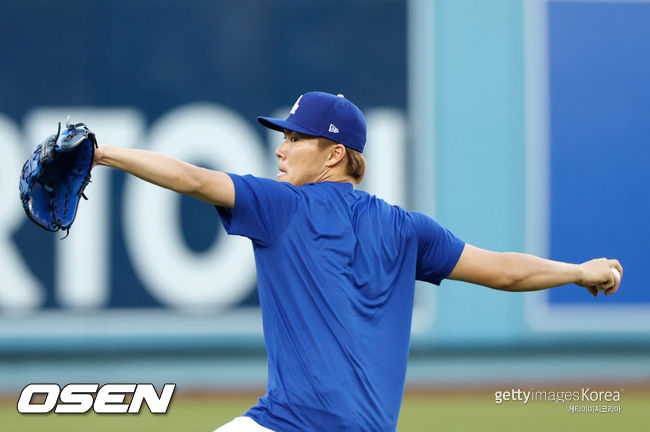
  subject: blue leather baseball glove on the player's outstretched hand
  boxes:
[20,119,97,237]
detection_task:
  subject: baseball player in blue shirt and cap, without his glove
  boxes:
[94,92,623,432]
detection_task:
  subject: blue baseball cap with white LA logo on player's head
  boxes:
[257,92,366,153]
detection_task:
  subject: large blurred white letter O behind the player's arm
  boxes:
[122,104,265,310]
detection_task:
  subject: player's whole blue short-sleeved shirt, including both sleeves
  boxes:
[218,175,464,432]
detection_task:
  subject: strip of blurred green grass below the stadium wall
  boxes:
[0,391,650,432]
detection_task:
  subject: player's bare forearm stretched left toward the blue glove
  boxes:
[93,145,235,208]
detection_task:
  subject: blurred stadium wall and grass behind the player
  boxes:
[0,0,650,431]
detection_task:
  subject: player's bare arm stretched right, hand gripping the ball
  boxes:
[448,244,623,296]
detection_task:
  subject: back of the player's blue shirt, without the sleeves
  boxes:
[246,183,417,431]
